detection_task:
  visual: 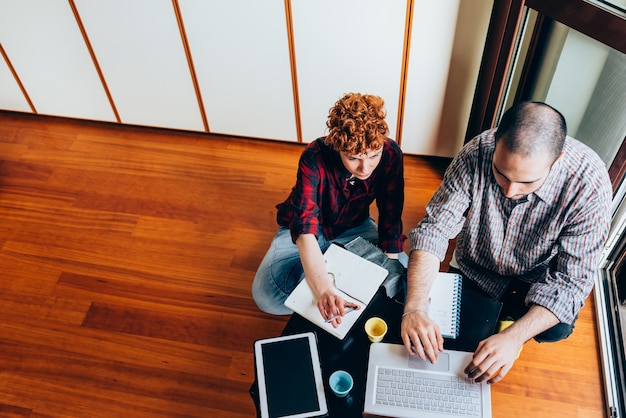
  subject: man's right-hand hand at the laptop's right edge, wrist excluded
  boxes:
[464,332,523,384]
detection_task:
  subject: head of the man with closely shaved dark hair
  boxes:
[492,102,567,200]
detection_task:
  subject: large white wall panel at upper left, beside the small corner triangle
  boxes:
[0,0,115,121]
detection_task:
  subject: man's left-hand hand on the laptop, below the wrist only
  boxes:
[400,310,443,363]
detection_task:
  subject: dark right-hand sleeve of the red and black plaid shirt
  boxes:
[376,139,405,253]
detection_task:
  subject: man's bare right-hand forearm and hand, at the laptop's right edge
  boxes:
[465,305,559,384]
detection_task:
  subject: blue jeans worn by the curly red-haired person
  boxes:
[252,218,378,315]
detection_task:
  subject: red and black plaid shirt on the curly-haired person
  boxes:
[276,138,405,253]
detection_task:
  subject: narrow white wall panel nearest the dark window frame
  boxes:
[402,0,459,156]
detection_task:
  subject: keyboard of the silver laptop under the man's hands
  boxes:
[376,367,481,417]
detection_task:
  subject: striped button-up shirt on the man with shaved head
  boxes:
[409,129,612,324]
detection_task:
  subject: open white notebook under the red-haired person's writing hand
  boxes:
[285,244,389,340]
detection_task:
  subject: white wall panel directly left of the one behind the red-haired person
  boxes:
[180,0,297,141]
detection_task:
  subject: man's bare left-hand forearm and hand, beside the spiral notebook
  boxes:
[401,250,443,363]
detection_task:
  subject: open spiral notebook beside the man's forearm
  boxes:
[427,272,463,338]
